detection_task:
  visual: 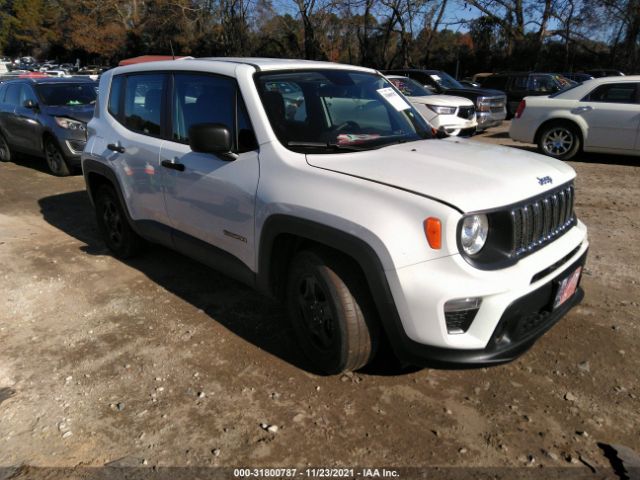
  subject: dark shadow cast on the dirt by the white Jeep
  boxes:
[38,191,407,375]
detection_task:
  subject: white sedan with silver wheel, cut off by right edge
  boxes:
[509,76,640,160]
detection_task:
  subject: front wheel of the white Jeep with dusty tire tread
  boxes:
[286,250,379,374]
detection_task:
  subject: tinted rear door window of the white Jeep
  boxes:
[124,74,165,136]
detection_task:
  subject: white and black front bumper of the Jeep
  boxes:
[387,223,588,366]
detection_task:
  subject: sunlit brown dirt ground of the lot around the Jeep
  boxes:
[0,122,640,479]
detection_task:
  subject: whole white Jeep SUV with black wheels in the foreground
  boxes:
[82,58,588,373]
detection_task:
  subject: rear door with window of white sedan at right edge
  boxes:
[573,82,640,151]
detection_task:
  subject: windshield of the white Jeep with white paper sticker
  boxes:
[256,70,432,153]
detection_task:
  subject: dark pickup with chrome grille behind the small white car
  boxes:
[383,69,506,131]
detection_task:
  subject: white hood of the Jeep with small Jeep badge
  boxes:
[307,137,575,213]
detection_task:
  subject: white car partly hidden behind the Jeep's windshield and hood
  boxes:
[387,75,478,136]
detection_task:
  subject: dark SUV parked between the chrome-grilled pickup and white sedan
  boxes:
[482,72,575,118]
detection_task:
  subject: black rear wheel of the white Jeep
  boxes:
[95,185,144,259]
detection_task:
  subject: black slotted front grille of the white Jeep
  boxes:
[510,185,575,256]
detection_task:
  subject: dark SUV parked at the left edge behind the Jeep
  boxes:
[0,77,98,176]
